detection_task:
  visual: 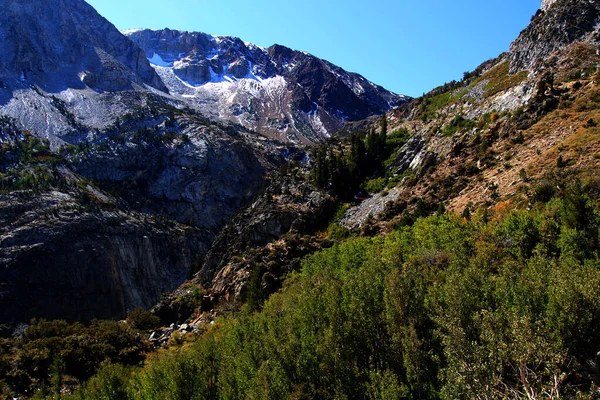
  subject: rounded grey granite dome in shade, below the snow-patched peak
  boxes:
[72,115,268,232]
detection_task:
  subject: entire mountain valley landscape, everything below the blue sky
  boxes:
[0,0,600,400]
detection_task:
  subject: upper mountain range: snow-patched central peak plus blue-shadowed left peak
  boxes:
[0,0,409,146]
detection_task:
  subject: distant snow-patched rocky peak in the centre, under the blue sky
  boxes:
[124,29,410,144]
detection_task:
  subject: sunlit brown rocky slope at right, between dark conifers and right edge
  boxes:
[344,0,600,229]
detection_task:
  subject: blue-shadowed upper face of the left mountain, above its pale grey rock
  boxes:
[0,0,166,91]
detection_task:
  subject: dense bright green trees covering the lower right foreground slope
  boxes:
[67,189,600,399]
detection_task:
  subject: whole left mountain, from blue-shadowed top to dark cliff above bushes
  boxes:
[0,0,286,326]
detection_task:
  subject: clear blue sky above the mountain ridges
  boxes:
[87,0,541,96]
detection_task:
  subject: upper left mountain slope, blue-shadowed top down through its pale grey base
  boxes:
[0,0,167,143]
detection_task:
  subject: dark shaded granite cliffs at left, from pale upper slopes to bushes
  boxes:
[0,111,283,325]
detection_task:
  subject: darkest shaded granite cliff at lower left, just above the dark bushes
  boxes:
[0,183,207,325]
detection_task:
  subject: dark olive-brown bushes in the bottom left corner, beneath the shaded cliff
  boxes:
[0,320,148,398]
